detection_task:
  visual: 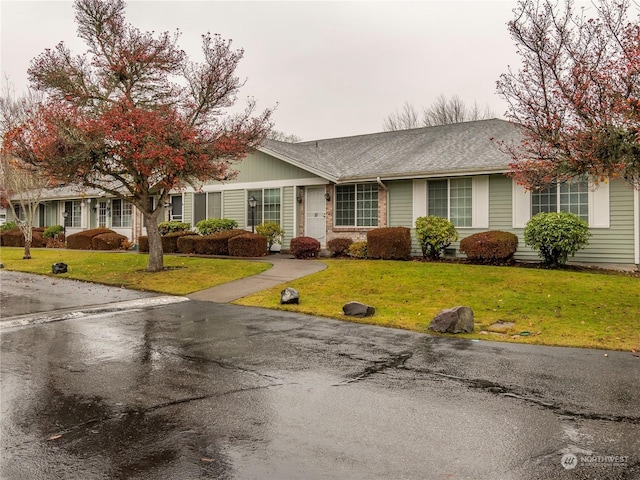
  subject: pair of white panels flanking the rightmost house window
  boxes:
[512,180,611,228]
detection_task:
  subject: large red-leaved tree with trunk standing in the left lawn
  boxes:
[3,0,272,271]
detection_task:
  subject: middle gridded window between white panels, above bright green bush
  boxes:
[427,178,473,227]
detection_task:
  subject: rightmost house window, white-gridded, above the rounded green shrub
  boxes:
[531,179,589,222]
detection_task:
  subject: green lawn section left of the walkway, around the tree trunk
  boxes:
[0,247,270,295]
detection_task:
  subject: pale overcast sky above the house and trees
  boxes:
[0,0,519,140]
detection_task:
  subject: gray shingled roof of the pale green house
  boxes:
[260,119,521,182]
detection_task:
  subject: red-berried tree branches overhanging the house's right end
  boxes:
[497,0,640,189]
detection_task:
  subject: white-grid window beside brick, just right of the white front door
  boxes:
[335,183,378,227]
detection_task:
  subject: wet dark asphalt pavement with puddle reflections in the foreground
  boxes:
[0,271,640,480]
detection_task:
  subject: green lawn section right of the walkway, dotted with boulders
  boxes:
[234,260,640,350]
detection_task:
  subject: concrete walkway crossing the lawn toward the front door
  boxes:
[187,254,327,303]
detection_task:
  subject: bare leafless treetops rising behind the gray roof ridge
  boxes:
[383,95,495,132]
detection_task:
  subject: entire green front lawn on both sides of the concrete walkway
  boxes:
[0,247,640,350]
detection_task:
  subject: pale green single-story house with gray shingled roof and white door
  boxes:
[6,119,640,265]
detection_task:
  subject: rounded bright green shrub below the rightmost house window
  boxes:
[524,212,591,268]
